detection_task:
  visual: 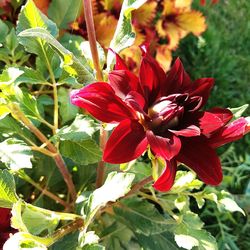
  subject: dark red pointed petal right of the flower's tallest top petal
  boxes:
[162,58,191,96]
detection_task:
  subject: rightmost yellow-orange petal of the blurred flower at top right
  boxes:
[176,10,207,36]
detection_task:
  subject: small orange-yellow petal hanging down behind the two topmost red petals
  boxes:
[156,45,172,72]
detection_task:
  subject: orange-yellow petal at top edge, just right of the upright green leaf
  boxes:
[132,2,157,25]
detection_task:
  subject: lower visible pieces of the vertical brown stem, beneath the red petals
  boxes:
[96,127,108,188]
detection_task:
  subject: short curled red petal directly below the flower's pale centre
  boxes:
[147,130,181,160]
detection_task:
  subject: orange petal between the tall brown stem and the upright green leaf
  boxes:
[94,13,117,48]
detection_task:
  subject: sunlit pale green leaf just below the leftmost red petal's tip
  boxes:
[56,114,100,141]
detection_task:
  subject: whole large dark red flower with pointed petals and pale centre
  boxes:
[71,48,249,191]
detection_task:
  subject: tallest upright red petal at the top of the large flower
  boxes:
[139,49,166,104]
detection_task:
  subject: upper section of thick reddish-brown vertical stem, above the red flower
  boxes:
[83,0,103,81]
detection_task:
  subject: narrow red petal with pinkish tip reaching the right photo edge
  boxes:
[209,117,248,148]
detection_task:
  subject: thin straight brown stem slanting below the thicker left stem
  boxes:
[18,171,70,208]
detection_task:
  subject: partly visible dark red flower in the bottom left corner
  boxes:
[0,208,16,249]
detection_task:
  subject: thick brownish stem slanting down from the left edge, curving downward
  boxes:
[10,105,76,201]
